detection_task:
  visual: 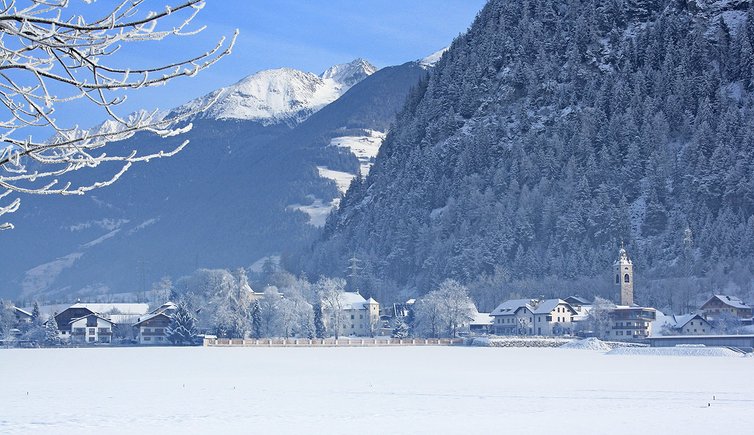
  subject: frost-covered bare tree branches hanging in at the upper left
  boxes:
[0,0,237,229]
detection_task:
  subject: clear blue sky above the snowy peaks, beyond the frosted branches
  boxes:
[58,0,485,127]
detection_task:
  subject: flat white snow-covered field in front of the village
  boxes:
[0,347,754,434]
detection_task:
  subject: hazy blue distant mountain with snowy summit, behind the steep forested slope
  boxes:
[0,59,426,300]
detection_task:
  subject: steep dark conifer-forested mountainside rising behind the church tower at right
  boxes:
[296,0,754,312]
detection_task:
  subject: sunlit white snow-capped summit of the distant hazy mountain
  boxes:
[174,59,377,126]
